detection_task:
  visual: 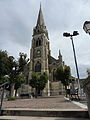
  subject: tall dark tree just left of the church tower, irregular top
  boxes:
[10,53,28,96]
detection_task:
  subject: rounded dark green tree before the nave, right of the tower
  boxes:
[55,65,71,90]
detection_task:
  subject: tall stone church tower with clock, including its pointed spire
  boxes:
[30,5,50,78]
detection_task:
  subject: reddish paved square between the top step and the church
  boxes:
[3,95,86,109]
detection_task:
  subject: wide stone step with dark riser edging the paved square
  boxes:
[2,108,89,118]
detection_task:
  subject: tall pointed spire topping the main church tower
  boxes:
[37,2,45,26]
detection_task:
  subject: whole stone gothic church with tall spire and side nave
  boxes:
[29,5,64,96]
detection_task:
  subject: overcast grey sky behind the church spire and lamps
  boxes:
[0,0,90,78]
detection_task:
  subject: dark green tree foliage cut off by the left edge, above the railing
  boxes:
[0,50,14,84]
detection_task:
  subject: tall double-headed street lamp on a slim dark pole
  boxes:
[63,31,80,93]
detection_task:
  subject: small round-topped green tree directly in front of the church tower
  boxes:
[30,72,48,97]
